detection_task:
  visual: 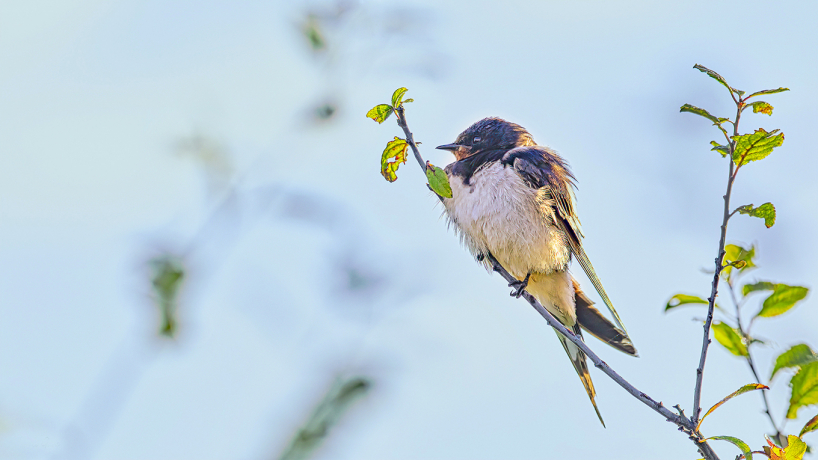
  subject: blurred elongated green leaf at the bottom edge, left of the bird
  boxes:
[279,377,372,460]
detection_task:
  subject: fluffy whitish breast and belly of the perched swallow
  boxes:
[443,162,570,279]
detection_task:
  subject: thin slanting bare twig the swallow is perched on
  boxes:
[395,106,719,460]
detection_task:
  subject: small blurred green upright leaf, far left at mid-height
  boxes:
[150,254,185,337]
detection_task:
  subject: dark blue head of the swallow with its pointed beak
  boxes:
[437,118,536,160]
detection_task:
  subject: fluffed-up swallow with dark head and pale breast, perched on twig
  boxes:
[437,117,638,427]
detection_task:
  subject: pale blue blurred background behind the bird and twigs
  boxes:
[0,0,818,459]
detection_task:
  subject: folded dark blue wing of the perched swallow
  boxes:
[502,146,627,333]
